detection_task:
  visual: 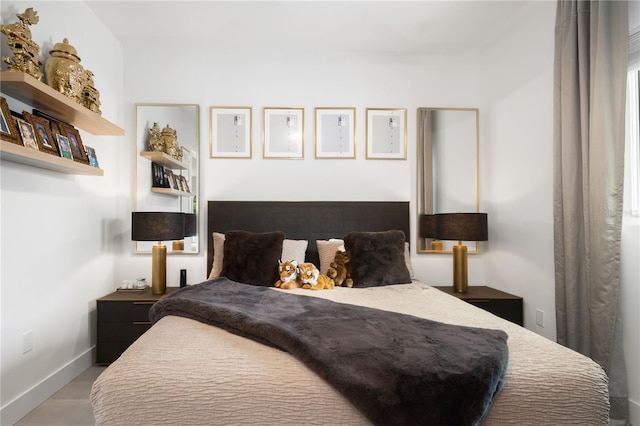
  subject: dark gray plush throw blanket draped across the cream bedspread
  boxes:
[149,278,508,425]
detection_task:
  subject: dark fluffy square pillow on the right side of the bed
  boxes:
[344,231,411,287]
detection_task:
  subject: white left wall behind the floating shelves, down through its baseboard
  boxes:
[0,1,128,425]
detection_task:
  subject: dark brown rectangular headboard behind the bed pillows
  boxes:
[207,201,410,275]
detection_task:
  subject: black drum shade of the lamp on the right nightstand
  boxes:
[435,213,489,241]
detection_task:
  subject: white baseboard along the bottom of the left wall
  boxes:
[0,347,95,425]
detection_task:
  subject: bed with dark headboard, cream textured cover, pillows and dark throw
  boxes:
[91,201,609,425]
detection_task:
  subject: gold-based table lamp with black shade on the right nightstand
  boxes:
[434,213,488,293]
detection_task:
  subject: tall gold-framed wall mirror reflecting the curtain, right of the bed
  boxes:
[416,108,480,253]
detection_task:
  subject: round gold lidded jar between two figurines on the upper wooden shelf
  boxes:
[44,38,87,103]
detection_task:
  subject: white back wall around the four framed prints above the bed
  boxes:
[121,43,481,283]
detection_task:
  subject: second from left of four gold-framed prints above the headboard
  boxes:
[262,107,304,158]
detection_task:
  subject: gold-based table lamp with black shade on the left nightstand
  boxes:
[131,212,185,294]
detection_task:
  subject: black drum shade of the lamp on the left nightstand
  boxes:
[131,212,185,241]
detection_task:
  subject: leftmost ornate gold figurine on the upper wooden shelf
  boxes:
[0,7,42,80]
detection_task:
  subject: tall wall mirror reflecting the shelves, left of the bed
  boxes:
[133,104,200,254]
